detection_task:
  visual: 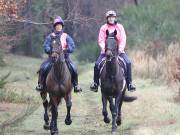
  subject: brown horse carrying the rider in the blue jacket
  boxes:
[41,37,72,135]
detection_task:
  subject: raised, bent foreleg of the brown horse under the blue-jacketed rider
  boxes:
[64,93,72,125]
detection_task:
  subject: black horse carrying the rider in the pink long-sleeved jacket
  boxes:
[100,30,126,132]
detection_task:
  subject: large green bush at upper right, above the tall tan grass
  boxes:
[119,0,180,47]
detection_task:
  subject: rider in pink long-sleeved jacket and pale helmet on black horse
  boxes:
[90,10,136,92]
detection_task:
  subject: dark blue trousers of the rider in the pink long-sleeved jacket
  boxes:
[94,53,132,85]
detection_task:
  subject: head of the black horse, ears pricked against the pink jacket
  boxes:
[105,30,118,60]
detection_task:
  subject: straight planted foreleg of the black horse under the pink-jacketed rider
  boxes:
[108,97,117,132]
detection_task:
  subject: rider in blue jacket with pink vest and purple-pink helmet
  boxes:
[36,16,82,92]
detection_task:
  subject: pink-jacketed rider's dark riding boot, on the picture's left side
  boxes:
[90,65,99,92]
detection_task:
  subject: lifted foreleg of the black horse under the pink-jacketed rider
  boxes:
[102,94,111,123]
